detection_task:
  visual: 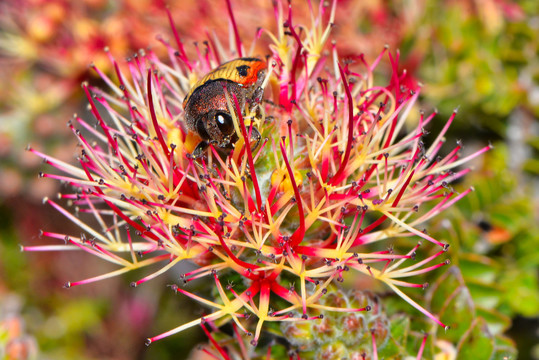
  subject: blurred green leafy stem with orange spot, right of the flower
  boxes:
[432,145,539,325]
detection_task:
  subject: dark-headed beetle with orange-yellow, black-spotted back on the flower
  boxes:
[183,57,267,158]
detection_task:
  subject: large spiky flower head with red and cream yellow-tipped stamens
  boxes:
[24,2,488,345]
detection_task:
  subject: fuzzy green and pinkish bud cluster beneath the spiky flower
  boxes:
[198,289,430,360]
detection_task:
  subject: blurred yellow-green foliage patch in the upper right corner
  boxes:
[410,1,539,138]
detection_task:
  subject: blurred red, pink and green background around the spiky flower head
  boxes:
[0,0,539,360]
